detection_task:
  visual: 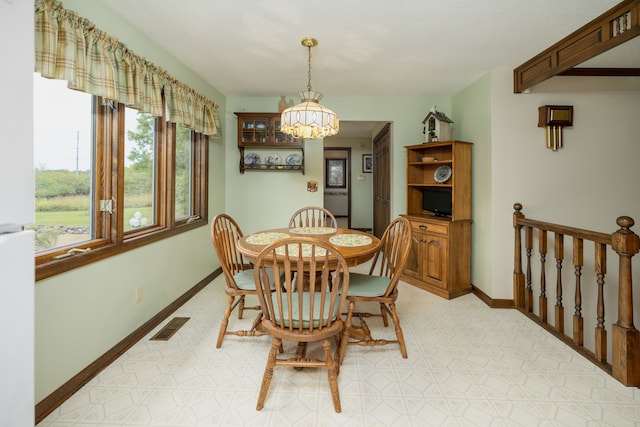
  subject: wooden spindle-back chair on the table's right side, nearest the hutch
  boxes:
[339,217,412,363]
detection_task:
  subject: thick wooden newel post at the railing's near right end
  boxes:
[611,216,640,387]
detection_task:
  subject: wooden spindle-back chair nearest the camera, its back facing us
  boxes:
[254,237,349,412]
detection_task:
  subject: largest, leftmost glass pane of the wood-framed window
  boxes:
[28,74,94,252]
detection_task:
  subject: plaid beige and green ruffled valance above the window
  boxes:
[35,0,220,136]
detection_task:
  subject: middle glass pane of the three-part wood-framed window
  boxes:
[124,108,156,231]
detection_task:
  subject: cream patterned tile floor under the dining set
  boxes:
[38,262,640,427]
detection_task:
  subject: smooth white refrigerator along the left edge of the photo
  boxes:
[0,0,35,427]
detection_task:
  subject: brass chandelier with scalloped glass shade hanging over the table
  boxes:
[280,37,340,139]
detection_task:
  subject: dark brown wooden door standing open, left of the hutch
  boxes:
[373,123,391,238]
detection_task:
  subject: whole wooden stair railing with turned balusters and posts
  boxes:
[513,203,640,387]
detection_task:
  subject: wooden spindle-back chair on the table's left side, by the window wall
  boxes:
[211,214,265,348]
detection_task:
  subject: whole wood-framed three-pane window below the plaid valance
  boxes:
[30,73,208,280]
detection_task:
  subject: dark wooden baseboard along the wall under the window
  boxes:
[35,268,222,424]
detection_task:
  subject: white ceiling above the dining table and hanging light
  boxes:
[101,0,636,135]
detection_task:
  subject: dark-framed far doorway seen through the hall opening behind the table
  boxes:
[324,147,351,228]
